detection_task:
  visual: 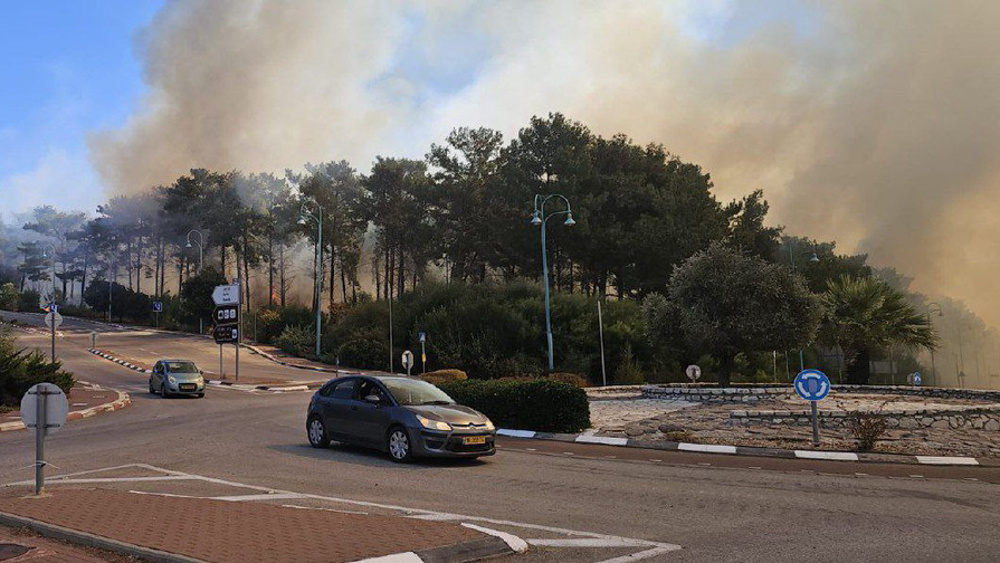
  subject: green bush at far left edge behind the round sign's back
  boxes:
[0,329,76,407]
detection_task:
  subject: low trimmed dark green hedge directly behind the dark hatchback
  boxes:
[439,379,590,433]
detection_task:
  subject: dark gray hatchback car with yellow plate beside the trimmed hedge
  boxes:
[306,376,496,462]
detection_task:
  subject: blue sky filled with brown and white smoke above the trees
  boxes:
[0,0,1000,325]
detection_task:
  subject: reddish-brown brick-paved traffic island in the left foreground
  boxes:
[0,487,510,563]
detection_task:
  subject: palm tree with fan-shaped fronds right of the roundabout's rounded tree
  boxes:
[820,275,938,384]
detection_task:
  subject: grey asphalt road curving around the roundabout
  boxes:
[0,313,1000,562]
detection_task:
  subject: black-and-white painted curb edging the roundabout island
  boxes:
[497,428,995,466]
